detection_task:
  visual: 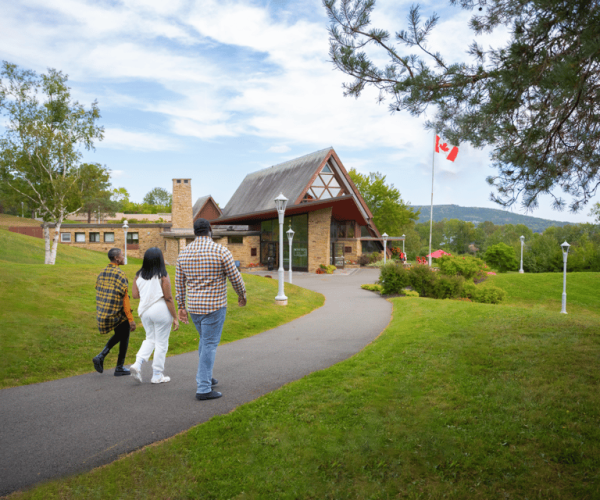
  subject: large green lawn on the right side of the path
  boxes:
[9,274,600,500]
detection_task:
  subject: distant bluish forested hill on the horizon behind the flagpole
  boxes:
[413,205,570,232]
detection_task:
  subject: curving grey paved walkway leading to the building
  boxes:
[0,269,392,495]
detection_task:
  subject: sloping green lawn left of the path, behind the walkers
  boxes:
[0,230,324,388]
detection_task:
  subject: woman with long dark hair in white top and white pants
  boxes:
[129,247,179,384]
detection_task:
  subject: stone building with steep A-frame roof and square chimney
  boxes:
[49,148,383,272]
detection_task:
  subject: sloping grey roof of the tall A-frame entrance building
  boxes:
[222,147,333,217]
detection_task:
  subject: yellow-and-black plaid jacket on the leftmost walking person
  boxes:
[96,264,129,333]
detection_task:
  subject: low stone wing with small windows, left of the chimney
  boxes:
[59,224,166,259]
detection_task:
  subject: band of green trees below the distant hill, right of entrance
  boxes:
[394,219,600,273]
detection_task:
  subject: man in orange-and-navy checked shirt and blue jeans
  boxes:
[175,219,246,401]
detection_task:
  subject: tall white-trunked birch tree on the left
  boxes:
[0,61,104,264]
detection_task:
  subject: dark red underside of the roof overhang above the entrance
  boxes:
[211,194,370,226]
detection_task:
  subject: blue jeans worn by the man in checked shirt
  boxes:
[190,307,227,394]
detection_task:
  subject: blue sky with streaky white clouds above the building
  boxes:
[0,0,600,222]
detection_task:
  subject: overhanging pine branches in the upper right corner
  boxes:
[324,0,600,211]
